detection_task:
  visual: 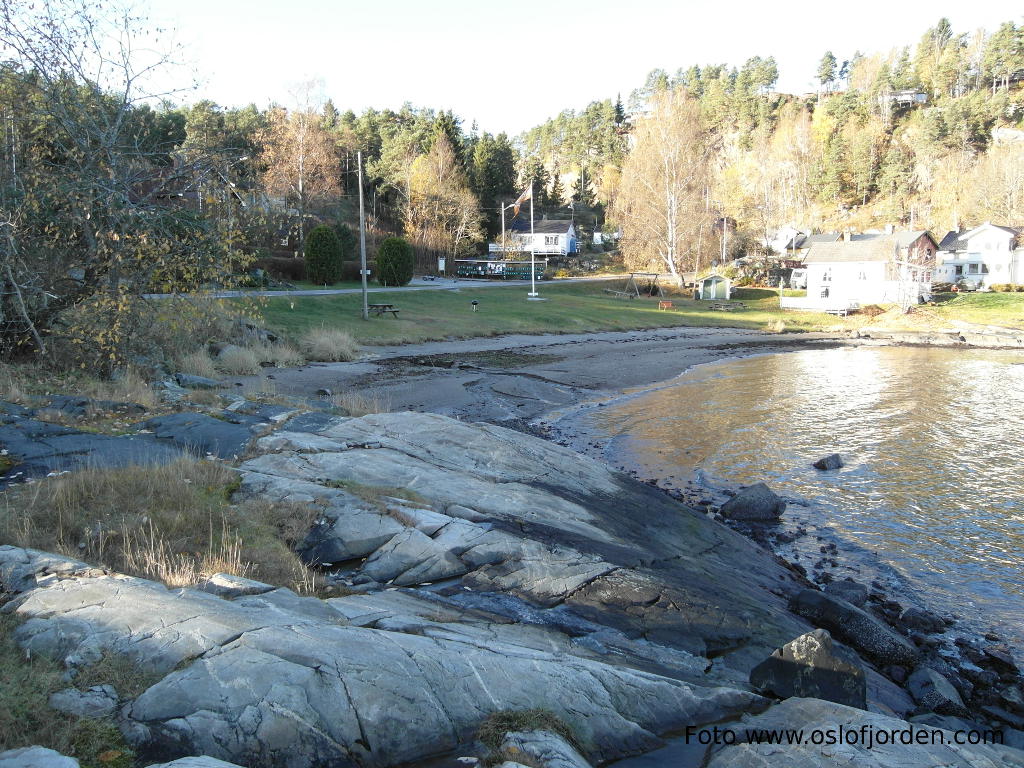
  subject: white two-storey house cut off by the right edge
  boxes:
[935,221,1024,288]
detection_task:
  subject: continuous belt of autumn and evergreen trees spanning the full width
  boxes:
[0,0,1024,364]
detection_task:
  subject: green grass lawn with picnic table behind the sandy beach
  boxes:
[243,283,843,344]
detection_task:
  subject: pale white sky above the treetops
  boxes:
[155,0,1024,135]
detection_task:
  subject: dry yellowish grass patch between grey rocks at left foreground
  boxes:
[0,459,319,592]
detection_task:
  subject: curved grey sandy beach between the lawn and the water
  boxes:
[239,328,856,426]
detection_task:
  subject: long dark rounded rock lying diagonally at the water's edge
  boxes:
[790,589,919,667]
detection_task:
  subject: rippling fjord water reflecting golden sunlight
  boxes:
[572,347,1024,648]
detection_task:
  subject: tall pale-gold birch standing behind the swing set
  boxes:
[612,89,716,278]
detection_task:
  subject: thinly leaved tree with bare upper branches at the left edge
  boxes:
[0,0,237,373]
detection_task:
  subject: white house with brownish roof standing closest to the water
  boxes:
[782,231,939,311]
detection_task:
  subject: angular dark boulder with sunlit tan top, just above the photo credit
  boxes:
[751,630,867,710]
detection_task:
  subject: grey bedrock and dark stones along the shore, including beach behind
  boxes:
[0,332,1024,768]
